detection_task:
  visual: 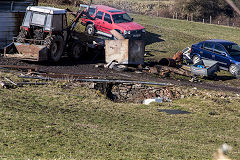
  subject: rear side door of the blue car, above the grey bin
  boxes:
[199,42,215,60]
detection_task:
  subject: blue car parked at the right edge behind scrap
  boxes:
[190,39,240,76]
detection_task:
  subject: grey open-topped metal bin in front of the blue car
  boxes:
[191,60,219,77]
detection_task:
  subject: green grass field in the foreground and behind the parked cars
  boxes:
[0,3,240,159]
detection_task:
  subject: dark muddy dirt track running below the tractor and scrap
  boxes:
[0,57,240,93]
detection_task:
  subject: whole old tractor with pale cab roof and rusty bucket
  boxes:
[5,6,92,62]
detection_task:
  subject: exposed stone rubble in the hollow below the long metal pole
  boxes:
[89,83,173,103]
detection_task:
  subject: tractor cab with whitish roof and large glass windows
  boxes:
[20,6,67,40]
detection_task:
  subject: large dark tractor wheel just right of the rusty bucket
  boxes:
[49,36,64,62]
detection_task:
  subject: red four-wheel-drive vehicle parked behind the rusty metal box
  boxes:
[82,5,146,39]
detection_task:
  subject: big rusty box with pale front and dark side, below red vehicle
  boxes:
[105,39,145,64]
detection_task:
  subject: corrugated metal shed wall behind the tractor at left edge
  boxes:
[0,0,38,49]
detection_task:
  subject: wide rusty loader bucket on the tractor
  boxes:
[5,42,48,61]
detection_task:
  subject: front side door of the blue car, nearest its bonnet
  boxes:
[214,43,230,69]
